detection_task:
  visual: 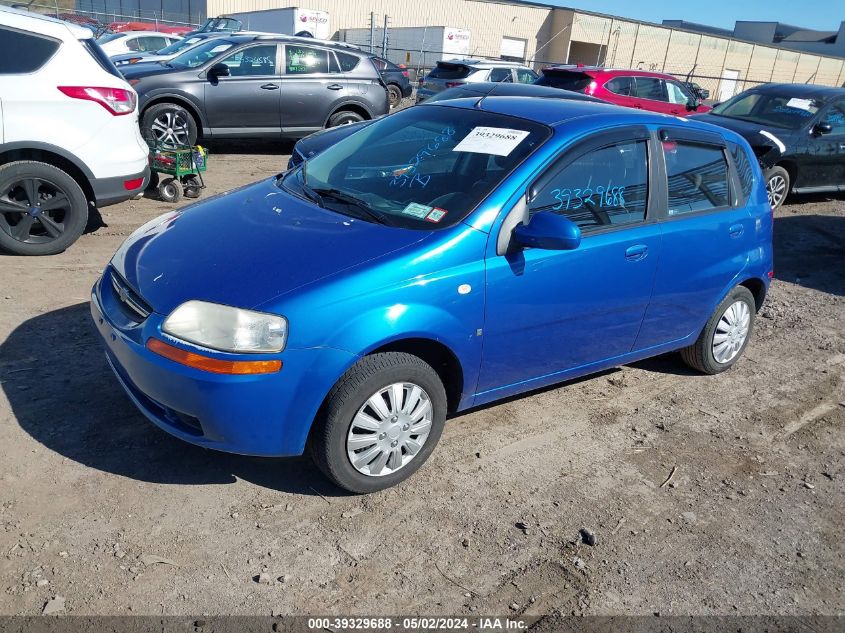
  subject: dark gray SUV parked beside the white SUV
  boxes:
[123,35,390,145]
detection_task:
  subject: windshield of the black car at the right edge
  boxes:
[712,92,822,130]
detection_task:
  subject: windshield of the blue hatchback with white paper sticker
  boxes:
[282,105,551,230]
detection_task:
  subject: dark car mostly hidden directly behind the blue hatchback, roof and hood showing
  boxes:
[288,81,606,169]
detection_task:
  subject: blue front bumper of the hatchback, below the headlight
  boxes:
[91,268,356,457]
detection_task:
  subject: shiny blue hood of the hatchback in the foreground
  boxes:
[112,179,431,314]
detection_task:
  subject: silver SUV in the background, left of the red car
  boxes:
[417,59,539,103]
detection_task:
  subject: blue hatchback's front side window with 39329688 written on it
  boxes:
[528,140,648,231]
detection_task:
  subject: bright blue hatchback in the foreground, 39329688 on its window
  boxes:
[91,97,772,493]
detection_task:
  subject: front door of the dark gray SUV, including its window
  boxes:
[205,44,281,136]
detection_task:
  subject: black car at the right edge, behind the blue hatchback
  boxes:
[695,84,845,208]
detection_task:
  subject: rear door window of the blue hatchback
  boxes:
[663,141,730,215]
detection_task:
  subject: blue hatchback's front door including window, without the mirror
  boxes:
[478,128,660,392]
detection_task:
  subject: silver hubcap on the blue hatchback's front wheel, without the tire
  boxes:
[346,382,432,477]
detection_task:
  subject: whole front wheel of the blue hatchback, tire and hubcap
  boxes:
[309,352,446,493]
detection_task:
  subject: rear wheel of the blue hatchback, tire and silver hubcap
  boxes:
[681,286,756,374]
